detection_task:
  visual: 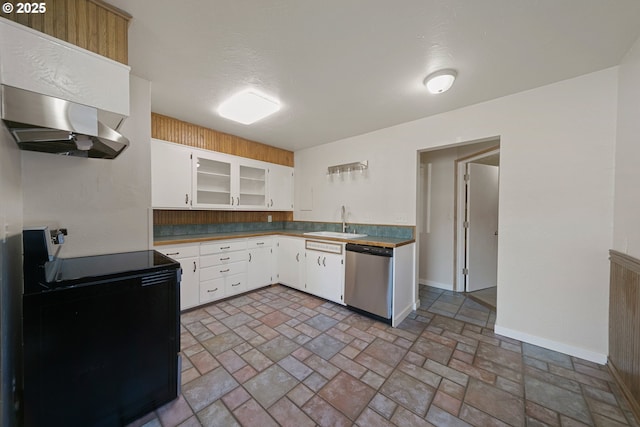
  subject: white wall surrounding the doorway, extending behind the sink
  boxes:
[294,67,618,362]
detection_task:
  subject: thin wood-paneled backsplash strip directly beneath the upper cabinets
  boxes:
[153,209,293,225]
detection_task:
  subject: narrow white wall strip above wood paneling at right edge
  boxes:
[613,35,640,258]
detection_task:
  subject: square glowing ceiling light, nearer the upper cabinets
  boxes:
[218,89,280,125]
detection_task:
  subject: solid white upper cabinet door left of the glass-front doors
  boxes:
[151,139,191,209]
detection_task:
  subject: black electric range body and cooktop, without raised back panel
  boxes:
[23,251,180,427]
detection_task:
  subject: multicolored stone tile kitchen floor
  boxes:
[131,285,638,427]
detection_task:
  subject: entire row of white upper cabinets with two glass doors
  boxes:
[151,139,293,211]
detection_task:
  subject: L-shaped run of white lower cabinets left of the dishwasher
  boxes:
[156,236,345,310]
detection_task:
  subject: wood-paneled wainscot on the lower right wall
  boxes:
[609,250,640,419]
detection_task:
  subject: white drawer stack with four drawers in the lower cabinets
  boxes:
[200,239,247,304]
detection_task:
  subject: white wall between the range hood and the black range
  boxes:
[22,76,151,257]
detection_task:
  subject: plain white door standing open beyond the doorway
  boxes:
[466,163,499,292]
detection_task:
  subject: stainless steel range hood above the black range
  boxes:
[0,85,129,159]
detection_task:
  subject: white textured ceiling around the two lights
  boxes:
[109,0,640,150]
